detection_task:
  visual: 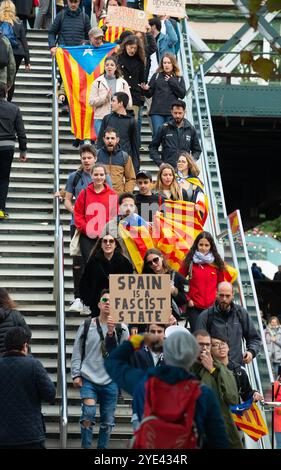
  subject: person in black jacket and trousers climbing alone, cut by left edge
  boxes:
[0,83,27,220]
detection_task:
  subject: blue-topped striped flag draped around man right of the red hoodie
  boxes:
[118,214,154,274]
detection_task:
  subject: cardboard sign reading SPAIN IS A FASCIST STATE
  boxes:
[109,274,171,323]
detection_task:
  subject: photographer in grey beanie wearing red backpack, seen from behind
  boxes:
[105,327,228,449]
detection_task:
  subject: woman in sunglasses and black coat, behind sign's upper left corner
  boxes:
[80,233,133,317]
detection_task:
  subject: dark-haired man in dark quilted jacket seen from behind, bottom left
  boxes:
[0,326,56,449]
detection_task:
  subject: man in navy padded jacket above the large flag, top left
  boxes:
[48,0,91,56]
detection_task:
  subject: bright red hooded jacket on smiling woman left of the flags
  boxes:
[74,183,118,238]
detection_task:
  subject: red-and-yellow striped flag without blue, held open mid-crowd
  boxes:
[152,200,203,271]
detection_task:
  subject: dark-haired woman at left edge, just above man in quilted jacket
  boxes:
[0,287,29,354]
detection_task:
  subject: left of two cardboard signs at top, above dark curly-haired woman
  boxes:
[107,5,148,32]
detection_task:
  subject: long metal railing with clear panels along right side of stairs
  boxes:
[181,16,273,448]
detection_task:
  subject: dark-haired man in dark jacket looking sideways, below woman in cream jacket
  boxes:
[97,91,140,173]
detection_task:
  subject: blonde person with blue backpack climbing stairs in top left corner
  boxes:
[0,0,30,101]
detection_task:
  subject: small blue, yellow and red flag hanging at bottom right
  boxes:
[230,398,268,441]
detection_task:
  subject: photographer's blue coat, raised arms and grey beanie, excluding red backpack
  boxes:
[105,327,228,449]
